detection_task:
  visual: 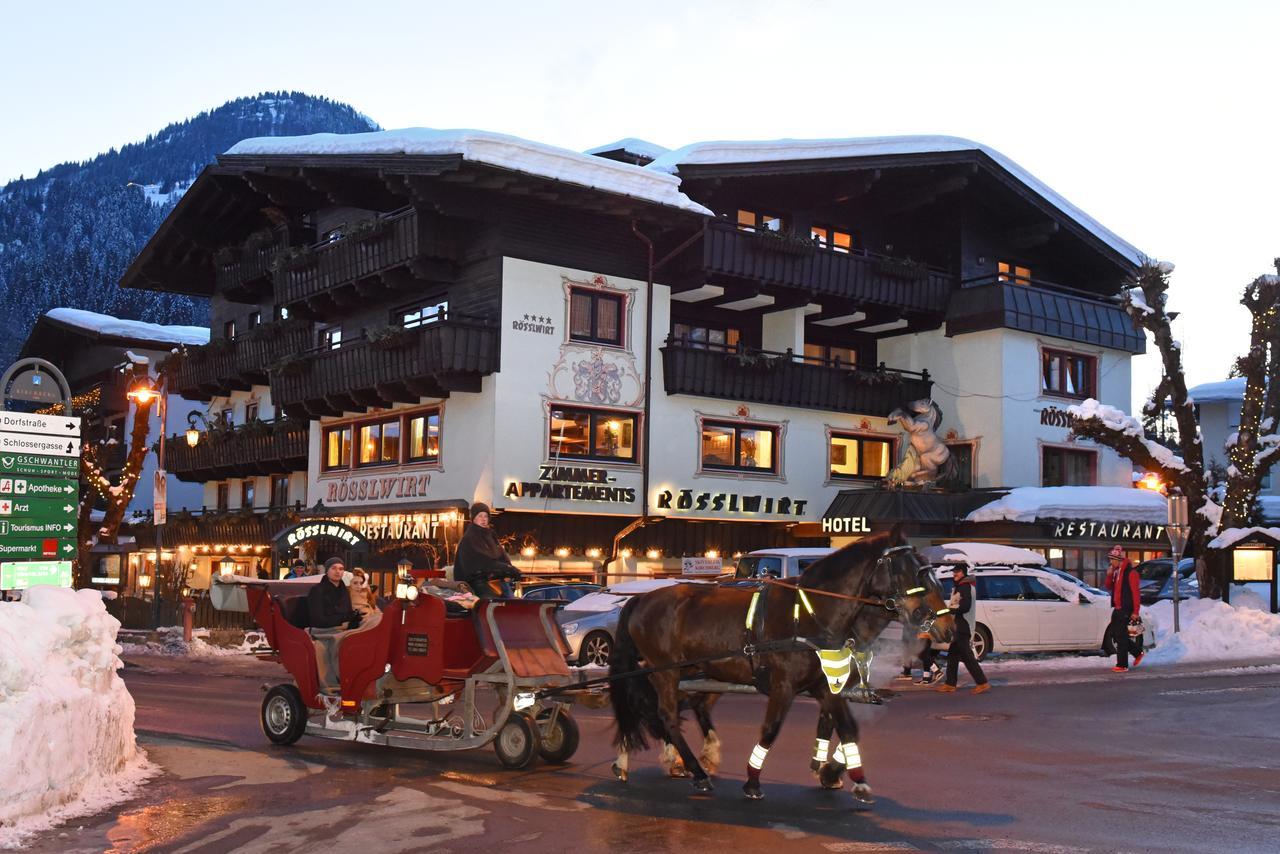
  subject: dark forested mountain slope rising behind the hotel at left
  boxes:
[0,92,379,369]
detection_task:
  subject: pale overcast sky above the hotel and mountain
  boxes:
[0,0,1280,407]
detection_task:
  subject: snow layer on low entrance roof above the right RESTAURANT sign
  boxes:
[965,487,1169,525]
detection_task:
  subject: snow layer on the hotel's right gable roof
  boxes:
[645,136,1143,265]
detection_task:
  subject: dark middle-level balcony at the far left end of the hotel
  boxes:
[169,320,312,401]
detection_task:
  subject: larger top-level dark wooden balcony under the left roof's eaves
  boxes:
[275,207,453,315]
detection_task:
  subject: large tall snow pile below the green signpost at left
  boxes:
[0,586,154,846]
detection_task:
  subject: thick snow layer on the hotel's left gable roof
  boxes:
[227,128,710,215]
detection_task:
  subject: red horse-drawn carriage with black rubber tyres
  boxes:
[242,581,579,768]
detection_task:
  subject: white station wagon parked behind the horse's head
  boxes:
[920,543,1156,659]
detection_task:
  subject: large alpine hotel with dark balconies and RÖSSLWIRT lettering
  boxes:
[123,129,1144,588]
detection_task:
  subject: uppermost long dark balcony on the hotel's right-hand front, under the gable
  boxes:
[703,222,960,314]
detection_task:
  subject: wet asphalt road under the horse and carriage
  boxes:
[31,657,1280,854]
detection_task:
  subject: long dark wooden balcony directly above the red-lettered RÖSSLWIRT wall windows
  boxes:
[271,315,499,417]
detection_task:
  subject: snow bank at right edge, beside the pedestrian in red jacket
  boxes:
[1146,588,1280,663]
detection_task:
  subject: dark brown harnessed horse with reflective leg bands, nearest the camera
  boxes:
[609,529,954,800]
